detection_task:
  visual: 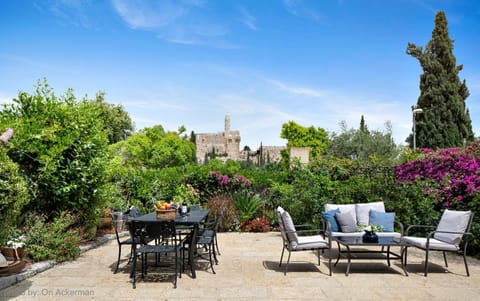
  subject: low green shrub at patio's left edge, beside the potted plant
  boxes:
[24,211,80,262]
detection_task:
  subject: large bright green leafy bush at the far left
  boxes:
[0,81,107,219]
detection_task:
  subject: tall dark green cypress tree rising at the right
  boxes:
[406,11,474,148]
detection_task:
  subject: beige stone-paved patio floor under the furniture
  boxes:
[0,232,480,301]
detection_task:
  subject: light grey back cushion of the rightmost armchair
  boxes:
[433,209,471,245]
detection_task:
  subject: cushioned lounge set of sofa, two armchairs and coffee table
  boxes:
[276,202,473,276]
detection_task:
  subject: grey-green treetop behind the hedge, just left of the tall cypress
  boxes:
[327,116,400,165]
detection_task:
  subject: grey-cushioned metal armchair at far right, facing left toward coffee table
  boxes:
[402,209,473,277]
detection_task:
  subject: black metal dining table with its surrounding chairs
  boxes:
[112,206,224,288]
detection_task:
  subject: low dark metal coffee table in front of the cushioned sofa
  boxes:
[331,236,408,276]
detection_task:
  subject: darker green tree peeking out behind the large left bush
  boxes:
[91,92,134,144]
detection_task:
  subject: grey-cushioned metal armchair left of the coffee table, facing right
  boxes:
[276,206,332,276]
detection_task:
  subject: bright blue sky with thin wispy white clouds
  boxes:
[0,0,480,148]
